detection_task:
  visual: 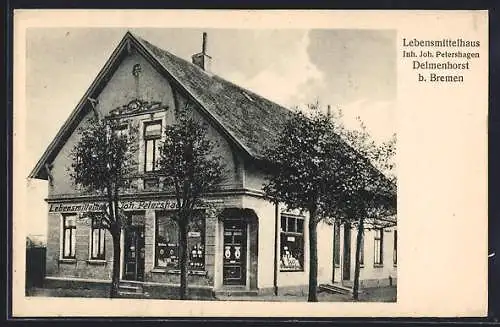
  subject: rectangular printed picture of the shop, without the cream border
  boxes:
[26,28,397,302]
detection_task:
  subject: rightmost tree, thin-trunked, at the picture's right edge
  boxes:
[331,110,396,300]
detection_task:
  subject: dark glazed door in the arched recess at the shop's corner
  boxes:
[223,221,247,285]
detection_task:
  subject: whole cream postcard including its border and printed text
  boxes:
[13,11,487,316]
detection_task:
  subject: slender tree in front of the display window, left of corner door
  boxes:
[159,104,224,299]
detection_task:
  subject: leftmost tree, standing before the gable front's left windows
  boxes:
[70,117,136,298]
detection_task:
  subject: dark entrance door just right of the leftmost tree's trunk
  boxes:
[124,225,145,281]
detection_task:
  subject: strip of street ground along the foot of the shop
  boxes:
[26,286,396,302]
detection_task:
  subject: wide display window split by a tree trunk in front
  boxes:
[155,212,205,271]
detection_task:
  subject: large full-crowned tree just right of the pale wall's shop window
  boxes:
[264,111,353,302]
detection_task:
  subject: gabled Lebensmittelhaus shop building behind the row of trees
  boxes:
[30,33,396,293]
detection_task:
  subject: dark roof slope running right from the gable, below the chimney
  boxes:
[135,36,292,159]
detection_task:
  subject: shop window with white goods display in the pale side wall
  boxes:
[280,214,304,271]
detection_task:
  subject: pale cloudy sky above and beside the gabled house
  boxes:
[25,28,397,235]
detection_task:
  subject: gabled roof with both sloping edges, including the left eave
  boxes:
[29,32,291,179]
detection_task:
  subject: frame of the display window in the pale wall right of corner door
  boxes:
[279,213,305,272]
